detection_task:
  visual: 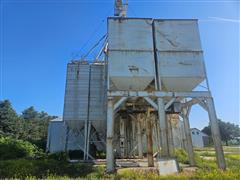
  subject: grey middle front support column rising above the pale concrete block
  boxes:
[158,98,169,157]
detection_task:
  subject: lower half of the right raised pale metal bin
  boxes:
[158,52,205,91]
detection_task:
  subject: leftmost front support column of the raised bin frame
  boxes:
[107,98,115,172]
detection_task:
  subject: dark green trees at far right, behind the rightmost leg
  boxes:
[202,120,240,146]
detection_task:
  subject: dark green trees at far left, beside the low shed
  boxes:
[0,100,57,149]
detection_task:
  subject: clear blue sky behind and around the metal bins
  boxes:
[0,0,240,128]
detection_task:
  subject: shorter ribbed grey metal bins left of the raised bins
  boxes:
[63,61,106,132]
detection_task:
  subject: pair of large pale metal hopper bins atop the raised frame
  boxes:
[108,18,205,92]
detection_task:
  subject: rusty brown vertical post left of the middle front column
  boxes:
[147,110,154,167]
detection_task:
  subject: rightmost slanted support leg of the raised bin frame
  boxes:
[207,98,226,170]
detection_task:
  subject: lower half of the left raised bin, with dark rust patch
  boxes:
[108,51,155,90]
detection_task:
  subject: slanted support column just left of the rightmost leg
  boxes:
[183,108,195,166]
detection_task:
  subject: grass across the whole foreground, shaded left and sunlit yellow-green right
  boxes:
[0,148,240,180]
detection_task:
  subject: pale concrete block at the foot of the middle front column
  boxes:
[157,159,179,175]
